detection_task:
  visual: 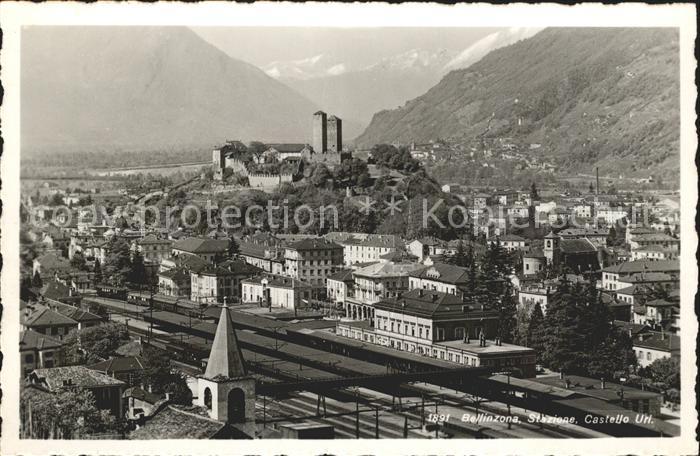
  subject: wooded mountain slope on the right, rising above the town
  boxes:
[356,28,680,180]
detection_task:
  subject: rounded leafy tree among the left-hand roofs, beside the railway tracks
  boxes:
[61,322,130,365]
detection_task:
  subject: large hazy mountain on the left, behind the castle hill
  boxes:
[21,26,318,152]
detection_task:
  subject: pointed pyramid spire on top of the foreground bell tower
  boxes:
[204,303,246,379]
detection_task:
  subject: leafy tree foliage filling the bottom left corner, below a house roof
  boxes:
[20,388,122,439]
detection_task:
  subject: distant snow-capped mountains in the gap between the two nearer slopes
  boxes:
[263,27,540,134]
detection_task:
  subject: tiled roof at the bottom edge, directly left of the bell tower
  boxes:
[129,405,226,440]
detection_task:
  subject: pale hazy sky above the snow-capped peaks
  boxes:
[192,27,501,66]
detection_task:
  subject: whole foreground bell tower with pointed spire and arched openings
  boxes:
[197,304,255,437]
